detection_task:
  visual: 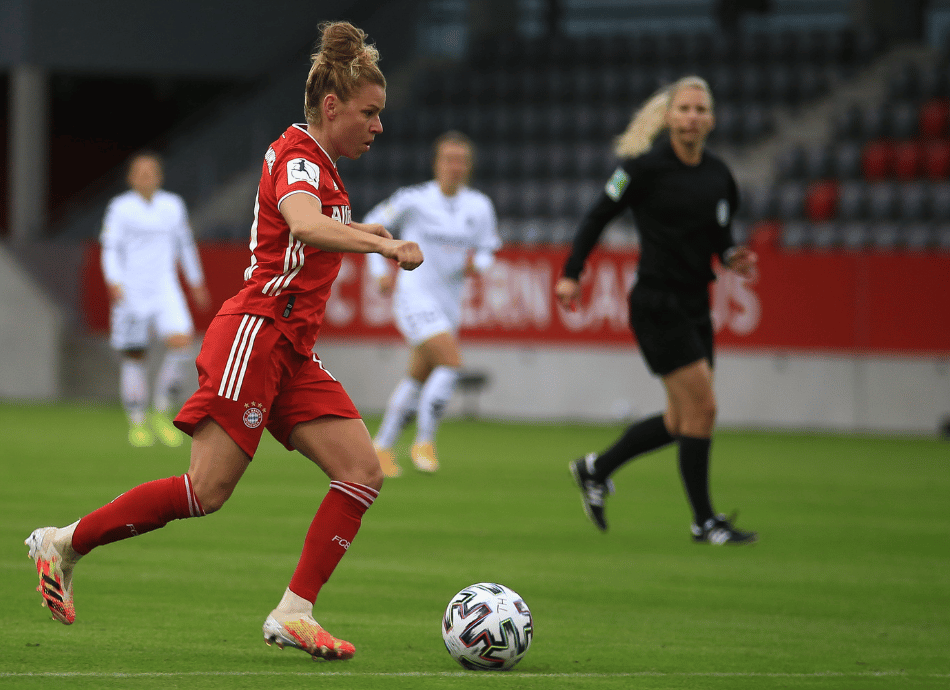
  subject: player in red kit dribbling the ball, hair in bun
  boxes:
[26,22,422,660]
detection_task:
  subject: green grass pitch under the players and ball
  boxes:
[0,404,950,690]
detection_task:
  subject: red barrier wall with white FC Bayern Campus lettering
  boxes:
[81,243,950,354]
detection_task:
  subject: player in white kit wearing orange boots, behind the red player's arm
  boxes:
[365,131,501,477]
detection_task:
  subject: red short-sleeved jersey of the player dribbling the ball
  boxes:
[218,124,350,357]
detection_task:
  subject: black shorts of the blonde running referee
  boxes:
[630,284,713,376]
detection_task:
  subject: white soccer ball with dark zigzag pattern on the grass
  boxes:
[442,582,534,671]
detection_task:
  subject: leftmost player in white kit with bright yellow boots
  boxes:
[100,152,211,447]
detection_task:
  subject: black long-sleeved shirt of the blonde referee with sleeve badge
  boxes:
[564,137,739,292]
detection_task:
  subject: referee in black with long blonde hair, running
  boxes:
[555,76,758,544]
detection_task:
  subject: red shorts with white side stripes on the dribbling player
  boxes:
[175,314,360,458]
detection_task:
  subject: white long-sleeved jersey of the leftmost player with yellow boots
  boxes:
[100,189,204,306]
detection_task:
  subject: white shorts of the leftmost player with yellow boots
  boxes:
[109,290,195,350]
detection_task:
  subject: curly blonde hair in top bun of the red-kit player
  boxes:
[304,22,386,125]
